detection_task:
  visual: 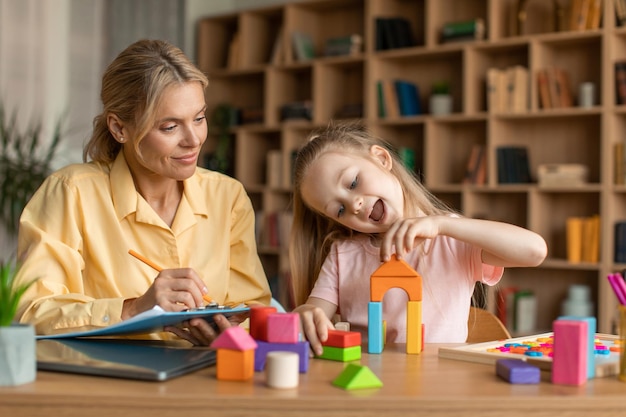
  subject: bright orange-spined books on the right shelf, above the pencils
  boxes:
[565,214,600,263]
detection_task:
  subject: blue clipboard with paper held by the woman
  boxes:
[37,306,250,339]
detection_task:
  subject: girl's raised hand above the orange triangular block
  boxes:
[380,216,440,262]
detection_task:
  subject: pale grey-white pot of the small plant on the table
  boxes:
[0,324,37,386]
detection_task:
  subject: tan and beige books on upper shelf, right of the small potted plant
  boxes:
[486,65,530,113]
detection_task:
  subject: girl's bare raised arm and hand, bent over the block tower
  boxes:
[380,215,548,267]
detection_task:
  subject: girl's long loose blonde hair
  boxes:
[289,123,452,305]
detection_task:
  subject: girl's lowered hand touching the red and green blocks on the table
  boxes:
[293,297,337,355]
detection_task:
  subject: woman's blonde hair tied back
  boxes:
[83,40,209,163]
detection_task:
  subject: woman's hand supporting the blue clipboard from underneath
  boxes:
[164,313,248,346]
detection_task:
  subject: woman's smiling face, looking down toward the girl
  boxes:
[124,82,207,181]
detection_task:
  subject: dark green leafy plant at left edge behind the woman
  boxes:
[0,103,61,237]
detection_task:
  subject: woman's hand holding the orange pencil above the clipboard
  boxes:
[122,268,208,319]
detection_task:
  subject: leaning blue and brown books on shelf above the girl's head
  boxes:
[376,80,422,118]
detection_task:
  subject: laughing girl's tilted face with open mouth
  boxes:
[301,146,404,233]
